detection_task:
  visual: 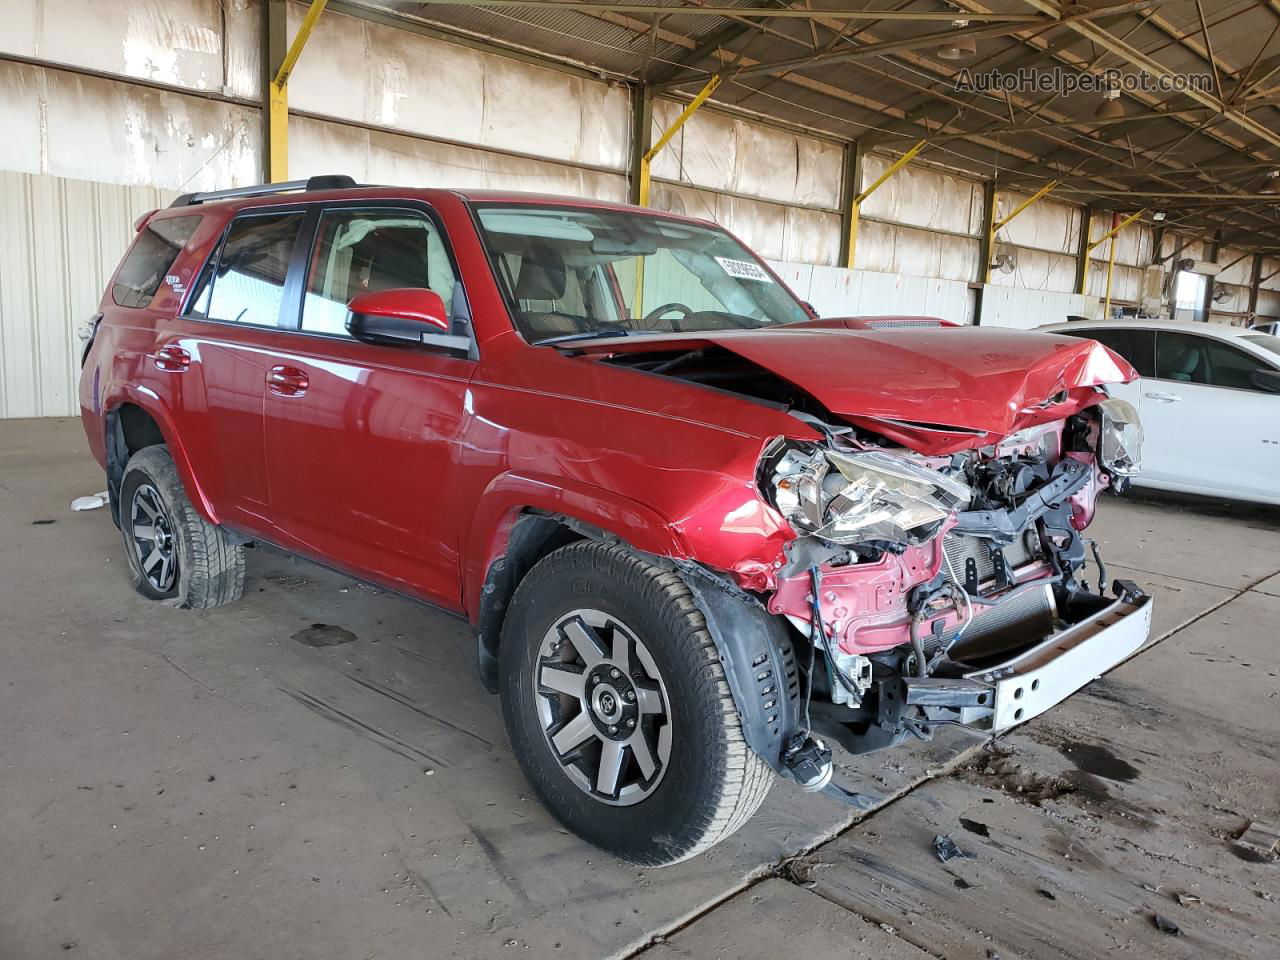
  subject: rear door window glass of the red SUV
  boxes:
[191,212,302,326]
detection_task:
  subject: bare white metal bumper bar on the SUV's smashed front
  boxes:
[906,596,1153,732]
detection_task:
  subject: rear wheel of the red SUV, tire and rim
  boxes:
[119,445,244,609]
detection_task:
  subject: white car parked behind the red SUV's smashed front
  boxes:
[1038,320,1280,503]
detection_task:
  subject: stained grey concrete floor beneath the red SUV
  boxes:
[0,420,1280,960]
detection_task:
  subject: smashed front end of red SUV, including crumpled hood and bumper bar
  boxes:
[573,317,1151,783]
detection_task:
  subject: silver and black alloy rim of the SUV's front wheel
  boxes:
[534,609,672,806]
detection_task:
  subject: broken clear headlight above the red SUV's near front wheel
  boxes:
[768,444,972,545]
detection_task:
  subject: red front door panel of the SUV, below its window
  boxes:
[259,343,472,608]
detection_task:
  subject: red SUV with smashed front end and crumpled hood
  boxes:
[79,177,1151,864]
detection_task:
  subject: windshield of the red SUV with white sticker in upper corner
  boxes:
[476,205,809,343]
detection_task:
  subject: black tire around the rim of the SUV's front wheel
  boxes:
[499,540,773,867]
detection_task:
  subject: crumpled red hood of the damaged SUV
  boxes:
[573,326,1137,453]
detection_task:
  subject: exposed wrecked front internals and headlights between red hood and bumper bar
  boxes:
[758,398,1142,753]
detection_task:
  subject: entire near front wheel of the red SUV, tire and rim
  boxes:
[499,541,773,867]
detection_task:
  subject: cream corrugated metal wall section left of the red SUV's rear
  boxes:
[0,173,173,417]
